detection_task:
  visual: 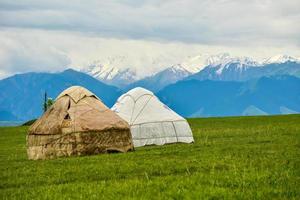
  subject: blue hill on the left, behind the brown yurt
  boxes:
[0,69,121,120]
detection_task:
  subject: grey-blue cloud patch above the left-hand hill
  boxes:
[0,31,71,74]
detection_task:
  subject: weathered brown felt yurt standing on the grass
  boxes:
[27,86,133,160]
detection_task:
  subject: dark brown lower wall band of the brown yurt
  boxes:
[27,130,133,160]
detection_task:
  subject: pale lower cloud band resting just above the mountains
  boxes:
[0,29,300,77]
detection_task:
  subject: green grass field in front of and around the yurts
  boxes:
[0,115,300,199]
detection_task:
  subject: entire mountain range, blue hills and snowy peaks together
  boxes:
[0,54,300,121]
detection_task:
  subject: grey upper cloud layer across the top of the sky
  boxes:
[0,0,300,45]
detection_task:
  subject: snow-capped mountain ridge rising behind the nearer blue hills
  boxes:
[82,53,300,92]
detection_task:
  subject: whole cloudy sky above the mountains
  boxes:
[0,0,300,78]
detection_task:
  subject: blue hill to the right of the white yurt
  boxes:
[157,75,300,117]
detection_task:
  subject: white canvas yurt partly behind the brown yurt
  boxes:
[112,87,194,147]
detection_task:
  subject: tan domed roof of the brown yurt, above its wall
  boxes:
[29,86,128,134]
